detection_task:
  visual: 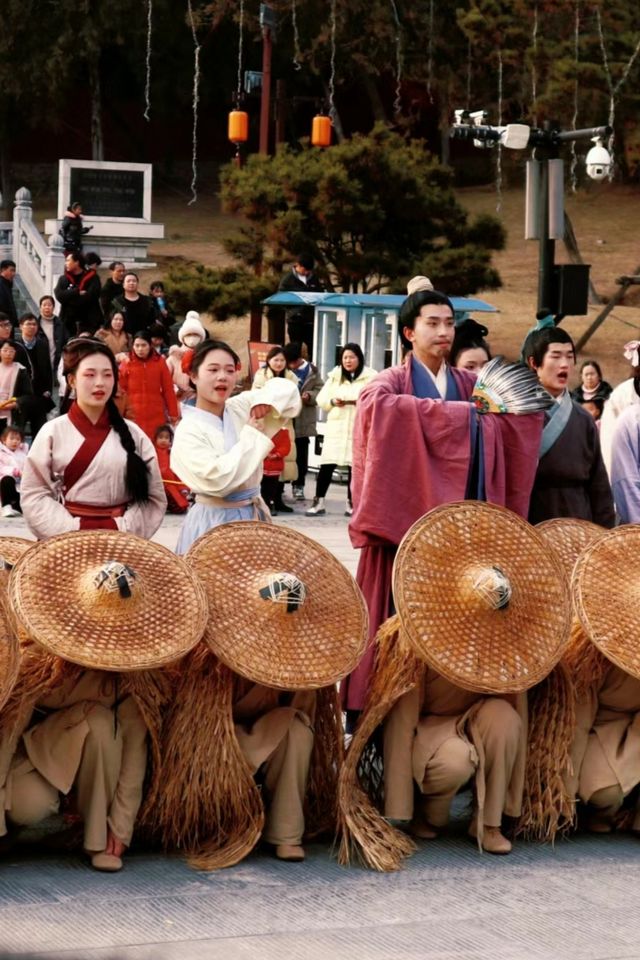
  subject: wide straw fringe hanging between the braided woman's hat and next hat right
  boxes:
[147,644,264,870]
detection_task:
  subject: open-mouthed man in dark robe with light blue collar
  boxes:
[523,327,615,527]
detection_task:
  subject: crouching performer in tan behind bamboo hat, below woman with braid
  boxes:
[0,531,207,872]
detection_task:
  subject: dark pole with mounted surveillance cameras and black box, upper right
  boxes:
[449,116,611,323]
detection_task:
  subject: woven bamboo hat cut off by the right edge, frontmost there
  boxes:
[572,524,640,679]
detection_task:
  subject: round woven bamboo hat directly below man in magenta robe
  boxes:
[393,501,571,693]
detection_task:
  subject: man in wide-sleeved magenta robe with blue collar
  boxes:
[342,290,542,711]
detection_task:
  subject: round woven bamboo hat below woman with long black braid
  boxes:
[8,530,207,671]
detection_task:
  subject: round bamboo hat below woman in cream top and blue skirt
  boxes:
[185,520,368,690]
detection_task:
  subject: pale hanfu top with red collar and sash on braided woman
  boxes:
[20,403,167,540]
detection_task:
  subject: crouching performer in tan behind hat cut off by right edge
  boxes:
[568,525,640,835]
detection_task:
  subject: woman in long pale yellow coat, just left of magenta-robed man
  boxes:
[307,343,376,517]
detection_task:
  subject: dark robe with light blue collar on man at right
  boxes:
[529,391,615,527]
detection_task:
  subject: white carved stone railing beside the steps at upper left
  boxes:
[12,187,64,305]
